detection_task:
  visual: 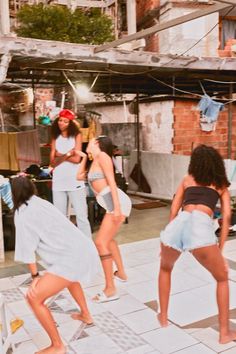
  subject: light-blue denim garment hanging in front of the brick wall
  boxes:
[198,95,224,123]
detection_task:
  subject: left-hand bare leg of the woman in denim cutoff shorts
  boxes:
[157,244,180,327]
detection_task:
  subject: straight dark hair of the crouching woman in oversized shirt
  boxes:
[11,176,36,210]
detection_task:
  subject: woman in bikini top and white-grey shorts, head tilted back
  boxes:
[77,136,132,302]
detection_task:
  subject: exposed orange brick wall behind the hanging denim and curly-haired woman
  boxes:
[172,101,236,159]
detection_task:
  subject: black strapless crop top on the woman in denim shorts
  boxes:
[183,186,220,211]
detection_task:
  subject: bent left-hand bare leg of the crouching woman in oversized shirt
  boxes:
[27,273,70,354]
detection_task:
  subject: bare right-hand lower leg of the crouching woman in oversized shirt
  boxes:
[68,282,93,324]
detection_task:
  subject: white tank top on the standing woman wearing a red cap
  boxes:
[52,135,85,191]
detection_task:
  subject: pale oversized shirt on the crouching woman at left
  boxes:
[14,196,99,282]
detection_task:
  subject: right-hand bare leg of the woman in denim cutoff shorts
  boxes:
[192,245,236,344]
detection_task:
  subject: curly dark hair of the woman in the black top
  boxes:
[188,145,230,189]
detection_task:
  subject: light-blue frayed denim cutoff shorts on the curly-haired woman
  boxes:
[160,210,217,252]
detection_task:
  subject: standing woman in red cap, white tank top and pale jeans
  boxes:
[50,109,91,237]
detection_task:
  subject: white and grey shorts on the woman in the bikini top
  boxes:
[96,186,132,216]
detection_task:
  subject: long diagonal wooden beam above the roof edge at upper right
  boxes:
[94,4,232,53]
